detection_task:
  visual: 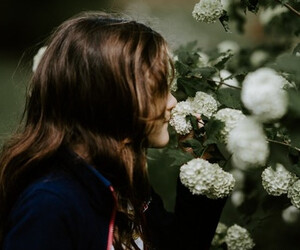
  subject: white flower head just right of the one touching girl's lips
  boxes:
[188,91,218,118]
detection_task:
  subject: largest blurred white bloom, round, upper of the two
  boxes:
[241,68,288,122]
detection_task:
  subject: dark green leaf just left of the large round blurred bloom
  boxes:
[217,88,242,109]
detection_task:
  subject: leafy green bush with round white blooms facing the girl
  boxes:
[146,0,300,249]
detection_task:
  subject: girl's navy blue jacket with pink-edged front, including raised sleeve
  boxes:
[3,149,225,250]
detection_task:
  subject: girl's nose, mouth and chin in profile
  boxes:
[148,93,177,148]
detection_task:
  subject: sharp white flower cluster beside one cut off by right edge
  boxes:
[261,163,298,196]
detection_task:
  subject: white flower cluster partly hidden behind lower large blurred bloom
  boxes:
[214,108,246,143]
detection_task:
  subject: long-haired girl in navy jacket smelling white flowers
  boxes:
[0,13,224,250]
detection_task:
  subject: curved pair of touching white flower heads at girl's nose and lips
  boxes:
[170,91,218,135]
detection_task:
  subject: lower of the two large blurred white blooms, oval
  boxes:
[227,117,269,170]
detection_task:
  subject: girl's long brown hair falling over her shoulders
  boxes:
[0,13,170,249]
